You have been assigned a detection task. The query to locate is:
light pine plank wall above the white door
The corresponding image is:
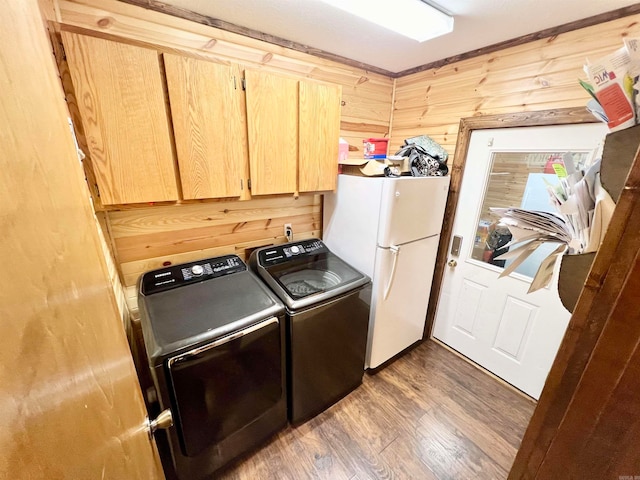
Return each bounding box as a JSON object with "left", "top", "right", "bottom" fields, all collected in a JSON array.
[{"left": 389, "top": 15, "right": 640, "bottom": 158}]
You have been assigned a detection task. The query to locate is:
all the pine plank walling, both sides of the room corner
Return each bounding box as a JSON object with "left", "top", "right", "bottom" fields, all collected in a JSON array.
[{"left": 52, "top": 0, "right": 640, "bottom": 316}]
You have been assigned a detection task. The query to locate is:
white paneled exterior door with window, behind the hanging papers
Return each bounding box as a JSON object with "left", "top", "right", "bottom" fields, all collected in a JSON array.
[{"left": 433, "top": 124, "right": 607, "bottom": 399}]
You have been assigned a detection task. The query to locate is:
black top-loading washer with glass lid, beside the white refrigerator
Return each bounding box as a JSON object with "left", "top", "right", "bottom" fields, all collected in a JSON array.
[{"left": 249, "top": 239, "right": 371, "bottom": 424}]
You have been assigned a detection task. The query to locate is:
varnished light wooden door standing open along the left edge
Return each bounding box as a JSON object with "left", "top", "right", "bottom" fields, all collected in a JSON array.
[{"left": 0, "top": 0, "right": 163, "bottom": 480}]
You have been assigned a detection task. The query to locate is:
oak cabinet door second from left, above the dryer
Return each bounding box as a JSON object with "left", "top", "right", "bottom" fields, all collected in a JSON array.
[{"left": 163, "top": 54, "right": 248, "bottom": 199}]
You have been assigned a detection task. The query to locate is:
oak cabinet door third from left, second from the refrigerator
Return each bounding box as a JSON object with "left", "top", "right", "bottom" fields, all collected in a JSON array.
[{"left": 245, "top": 70, "right": 298, "bottom": 195}]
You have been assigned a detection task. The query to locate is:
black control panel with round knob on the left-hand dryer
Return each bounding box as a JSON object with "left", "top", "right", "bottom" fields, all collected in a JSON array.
[{"left": 141, "top": 255, "right": 247, "bottom": 295}]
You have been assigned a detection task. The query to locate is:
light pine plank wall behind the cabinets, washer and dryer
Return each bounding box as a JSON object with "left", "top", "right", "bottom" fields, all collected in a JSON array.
[{"left": 52, "top": 0, "right": 393, "bottom": 313}]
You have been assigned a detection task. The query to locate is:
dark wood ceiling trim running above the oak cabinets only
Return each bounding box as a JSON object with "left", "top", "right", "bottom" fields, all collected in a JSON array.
[{"left": 119, "top": 0, "right": 396, "bottom": 78}]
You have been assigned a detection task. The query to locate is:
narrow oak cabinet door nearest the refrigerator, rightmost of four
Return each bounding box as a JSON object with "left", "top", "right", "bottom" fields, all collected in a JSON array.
[{"left": 298, "top": 81, "right": 342, "bottom": 192}]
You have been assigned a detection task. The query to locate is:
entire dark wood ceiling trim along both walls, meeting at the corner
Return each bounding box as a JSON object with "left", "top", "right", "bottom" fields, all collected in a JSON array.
[{"left": 119, "top": 0, "right": 640, "bottom": 78}]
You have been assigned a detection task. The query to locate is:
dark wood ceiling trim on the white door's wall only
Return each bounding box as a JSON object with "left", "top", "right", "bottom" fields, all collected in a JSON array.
[{"left": 394, "top": 3, "right": 640, "bottom": 78}]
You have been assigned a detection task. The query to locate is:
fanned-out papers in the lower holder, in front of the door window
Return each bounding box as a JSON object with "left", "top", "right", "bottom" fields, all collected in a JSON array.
[{"left": 490, "top": 161, "right": 615, "bottom": 293}]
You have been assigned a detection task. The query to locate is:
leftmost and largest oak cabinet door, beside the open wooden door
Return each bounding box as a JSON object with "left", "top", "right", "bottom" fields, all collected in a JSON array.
[{"left": 62, "top": 32, "right": 178, "bottom": 204}]
